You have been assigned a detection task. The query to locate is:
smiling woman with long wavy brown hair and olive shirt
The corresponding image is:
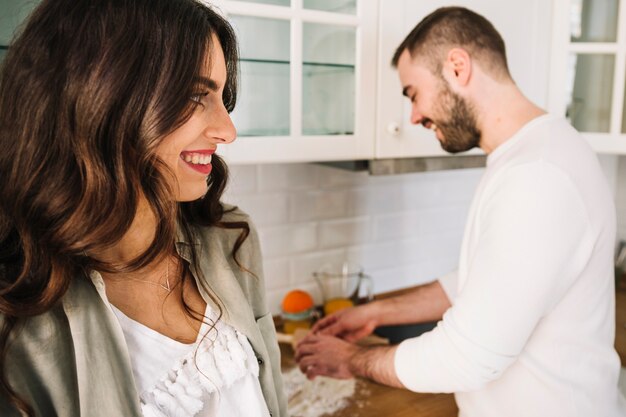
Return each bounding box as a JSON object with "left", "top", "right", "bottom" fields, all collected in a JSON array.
[{"left": 0, "top": 0, "right": 286, "bottom": 417}]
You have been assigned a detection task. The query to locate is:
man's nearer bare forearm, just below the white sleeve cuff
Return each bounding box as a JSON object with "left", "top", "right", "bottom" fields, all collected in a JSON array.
[{"left": 349, "top": 346, "right": 404, "bottom": 388}]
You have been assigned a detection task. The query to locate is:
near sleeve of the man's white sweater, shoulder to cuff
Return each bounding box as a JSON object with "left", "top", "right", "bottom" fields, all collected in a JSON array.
[{"left": 394, "top": 162, "right": 594, "bottom": 392}]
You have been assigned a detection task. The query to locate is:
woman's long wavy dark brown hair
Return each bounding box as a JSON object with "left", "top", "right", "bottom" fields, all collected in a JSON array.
[{"left": 0, "top": 0, "right": 249, "bottom": 415}]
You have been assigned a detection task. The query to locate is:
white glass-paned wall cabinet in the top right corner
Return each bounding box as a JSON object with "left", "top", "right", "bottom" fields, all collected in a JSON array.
[{"left": 549, "top": 0, "right": 626, "bottom": 154}]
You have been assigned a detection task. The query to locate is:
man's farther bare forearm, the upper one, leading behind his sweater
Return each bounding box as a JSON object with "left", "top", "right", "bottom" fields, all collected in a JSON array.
[{"left": 371, "top": 281, "right": 451, "bottom": 326}]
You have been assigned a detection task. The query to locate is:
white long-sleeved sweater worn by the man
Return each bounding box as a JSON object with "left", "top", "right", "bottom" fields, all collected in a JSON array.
[{"left": 395, "top": 115, "right": 626, "bottom": 417}]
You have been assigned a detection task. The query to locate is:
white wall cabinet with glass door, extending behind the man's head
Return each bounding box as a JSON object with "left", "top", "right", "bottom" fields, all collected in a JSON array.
[{"left": 217, "top": 0, "right": 552, "bottom": 163}]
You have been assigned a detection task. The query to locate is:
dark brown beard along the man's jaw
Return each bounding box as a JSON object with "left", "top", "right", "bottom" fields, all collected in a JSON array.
[{"left": 435, "top": 81, "right": 481, "bottom": 153}]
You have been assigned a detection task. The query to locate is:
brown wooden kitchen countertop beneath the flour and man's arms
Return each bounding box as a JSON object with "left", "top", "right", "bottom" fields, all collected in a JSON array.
[{"left": 281, "top": 288, "right": 626, "bottom": 417}]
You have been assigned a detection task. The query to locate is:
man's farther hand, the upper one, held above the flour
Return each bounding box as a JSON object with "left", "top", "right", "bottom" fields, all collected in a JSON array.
[{"left": 311, "top": 303, "right": 378, "bottom": 342}]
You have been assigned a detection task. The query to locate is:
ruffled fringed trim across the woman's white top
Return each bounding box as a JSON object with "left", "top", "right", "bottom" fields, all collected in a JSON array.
[{"left": 140, "top": 318, "right": 259, "bottom": 417}]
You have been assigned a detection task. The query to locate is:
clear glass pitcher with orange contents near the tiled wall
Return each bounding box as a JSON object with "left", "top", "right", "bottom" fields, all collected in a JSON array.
[{"left": 313, "top": 262, "right": 374, "bottom": 315}]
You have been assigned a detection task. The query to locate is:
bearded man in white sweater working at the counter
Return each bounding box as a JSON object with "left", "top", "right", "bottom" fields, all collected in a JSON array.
[{"left": 296, "top": 7, "right": 626, "bottom": 417}]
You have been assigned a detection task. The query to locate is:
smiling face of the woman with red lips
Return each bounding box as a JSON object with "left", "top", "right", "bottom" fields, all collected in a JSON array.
[{"left": 156, "top": 35, "right": 237, "bottom": 201}]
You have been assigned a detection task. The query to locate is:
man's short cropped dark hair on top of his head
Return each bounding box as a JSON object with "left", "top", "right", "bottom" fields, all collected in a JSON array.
[{"left": 391, "top": 7, "right": 511, "bottom": 79}]
